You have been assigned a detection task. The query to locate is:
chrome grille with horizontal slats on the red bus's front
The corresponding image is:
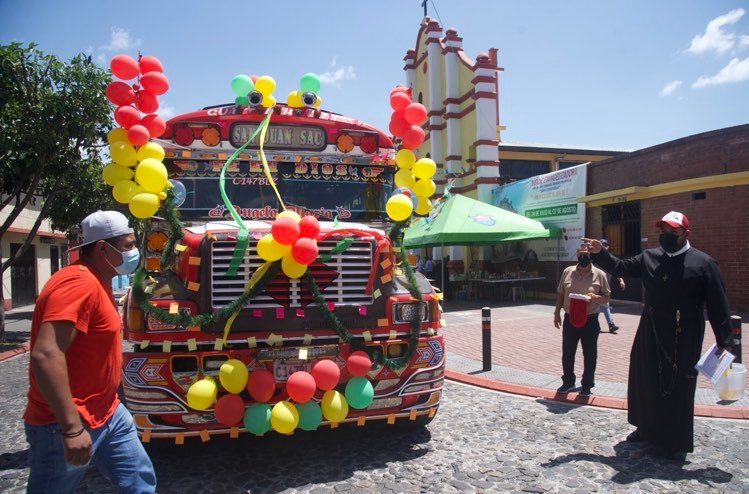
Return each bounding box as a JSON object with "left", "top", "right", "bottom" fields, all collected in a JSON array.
[{"left": 211, "top": 239, "right": 374, "bottom": 309}]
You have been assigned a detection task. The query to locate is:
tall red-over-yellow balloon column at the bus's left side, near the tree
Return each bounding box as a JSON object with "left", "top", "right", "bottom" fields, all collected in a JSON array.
[{"left": 102, "top": 55, "right": 169, "bottom": 218}]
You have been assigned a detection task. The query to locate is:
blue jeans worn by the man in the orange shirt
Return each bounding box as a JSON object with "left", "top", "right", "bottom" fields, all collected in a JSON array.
[{"left": 25, "top": 403, "right": 156, "bottom": 493}]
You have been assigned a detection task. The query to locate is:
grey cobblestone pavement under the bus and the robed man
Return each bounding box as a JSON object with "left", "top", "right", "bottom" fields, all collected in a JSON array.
[{"left": 0, "top": 354, "right": 749, "bottom": 494}]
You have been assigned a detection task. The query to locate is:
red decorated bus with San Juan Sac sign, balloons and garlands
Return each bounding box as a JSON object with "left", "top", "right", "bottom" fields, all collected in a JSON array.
[{"left": 113, "top": 68, "right": 445, "bottom": 443}]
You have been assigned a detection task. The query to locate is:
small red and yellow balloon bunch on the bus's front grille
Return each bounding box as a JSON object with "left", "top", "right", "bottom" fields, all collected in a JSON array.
[{"left": 257, "top": 211, "right": 320, "bottom": 279}]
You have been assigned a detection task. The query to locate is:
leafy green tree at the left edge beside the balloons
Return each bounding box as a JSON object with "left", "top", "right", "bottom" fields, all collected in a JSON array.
[{"left": 0, "top": 43, "right": 112, "bottom": 340}]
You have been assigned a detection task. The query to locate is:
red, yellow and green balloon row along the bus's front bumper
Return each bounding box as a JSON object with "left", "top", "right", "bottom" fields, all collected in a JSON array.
[{"left": 187, "top": 350, "right": 374, "bottom": 434}]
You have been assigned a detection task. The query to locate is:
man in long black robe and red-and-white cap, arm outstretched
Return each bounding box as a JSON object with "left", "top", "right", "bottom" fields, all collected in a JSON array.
[{"left": 583, "top": 211, "right": 731, "bottom": 457}]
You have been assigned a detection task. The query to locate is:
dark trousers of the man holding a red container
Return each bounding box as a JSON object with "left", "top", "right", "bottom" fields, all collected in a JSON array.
[{"left": 562, "top": 314, "right": 601, "bottom": 388}]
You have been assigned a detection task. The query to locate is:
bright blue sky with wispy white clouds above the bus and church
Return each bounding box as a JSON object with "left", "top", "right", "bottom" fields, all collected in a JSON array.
[{"left": 0, "top": 0, "right": 749, "bottom": 150}]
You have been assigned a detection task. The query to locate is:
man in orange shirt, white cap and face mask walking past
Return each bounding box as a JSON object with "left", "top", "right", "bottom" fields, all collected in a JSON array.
[{"left": 23, "top": 211, "right": 156, "bottom": 493}]
